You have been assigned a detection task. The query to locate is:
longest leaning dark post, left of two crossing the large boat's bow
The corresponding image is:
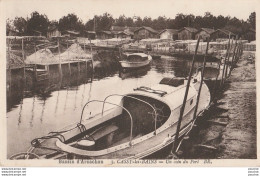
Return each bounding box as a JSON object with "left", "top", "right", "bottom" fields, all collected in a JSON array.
[{"left": 173, "top": 36, "right": 200, "bottom": 152}]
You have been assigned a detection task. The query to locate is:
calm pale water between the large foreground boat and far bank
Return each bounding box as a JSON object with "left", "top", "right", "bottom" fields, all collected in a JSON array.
[{"left": 7, "top": 57, "right": 211, "bottom": 157}]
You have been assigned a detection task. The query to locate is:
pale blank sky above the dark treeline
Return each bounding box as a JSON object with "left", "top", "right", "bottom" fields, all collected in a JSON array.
[{"left": 3, "top": 0, "right": 257, "bottom": 23}]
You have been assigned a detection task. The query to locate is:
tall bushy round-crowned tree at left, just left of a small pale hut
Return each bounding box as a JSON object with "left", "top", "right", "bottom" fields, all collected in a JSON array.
[{"left": 27, "top": 11, "right": 49, "bottom": 35}]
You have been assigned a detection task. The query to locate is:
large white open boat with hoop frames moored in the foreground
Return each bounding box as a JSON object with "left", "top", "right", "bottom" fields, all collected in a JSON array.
[{"left": 11, "top": 74, "right": 210, "bottom": 159}]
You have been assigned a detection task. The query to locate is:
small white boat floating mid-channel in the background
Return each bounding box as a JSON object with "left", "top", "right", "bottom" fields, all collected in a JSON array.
[{"left": 119, "top": 53, "right": 152, "bottom": 70}]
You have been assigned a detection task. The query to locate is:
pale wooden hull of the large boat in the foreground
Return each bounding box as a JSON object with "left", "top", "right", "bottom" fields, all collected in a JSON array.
[{"left": 18, "top": 82, "right": 210, "bottom": 159}]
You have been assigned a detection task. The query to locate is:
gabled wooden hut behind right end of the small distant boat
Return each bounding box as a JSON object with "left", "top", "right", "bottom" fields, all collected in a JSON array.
[{"left": 134, "top": 26, "right": 158, "bottom": 40}]
